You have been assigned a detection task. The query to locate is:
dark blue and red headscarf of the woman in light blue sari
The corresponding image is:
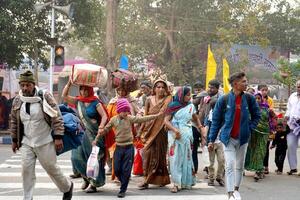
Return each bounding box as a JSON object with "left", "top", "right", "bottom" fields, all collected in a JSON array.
[{"left": 166, "top": 86, "right": 191, "bottom": 115}]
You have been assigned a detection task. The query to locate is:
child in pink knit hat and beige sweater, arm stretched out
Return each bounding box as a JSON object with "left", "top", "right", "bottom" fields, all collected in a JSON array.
[{"left": 93, "top": 98, "right": 163, "bottom": 198}]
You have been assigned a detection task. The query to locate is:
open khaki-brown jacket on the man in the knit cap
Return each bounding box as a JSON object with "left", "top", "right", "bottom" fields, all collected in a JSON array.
[{"left": 10, "top": 92, "right": 64, "bottom": 147}]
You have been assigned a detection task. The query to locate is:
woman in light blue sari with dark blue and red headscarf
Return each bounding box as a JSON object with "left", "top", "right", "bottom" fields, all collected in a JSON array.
[{"left": 165, "top": 87, "right": 202, "bottom": 193}]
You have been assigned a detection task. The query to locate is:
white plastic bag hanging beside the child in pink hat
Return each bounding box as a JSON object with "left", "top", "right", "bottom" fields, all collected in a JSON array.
[{"left": 86, "top": 146, "right": 99, "bottom": 180}]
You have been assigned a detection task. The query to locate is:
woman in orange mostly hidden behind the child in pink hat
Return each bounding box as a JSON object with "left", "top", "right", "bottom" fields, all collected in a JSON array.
[{"left": 105, "top": 87, "right": 139, "bottom": 180}]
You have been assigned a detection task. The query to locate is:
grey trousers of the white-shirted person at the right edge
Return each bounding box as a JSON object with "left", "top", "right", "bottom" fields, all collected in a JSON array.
[{"left": 287, "top": 132, "right": 300, "bottom": 169}]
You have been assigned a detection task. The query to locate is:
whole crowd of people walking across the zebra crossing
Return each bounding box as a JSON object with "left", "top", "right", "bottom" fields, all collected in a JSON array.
[{"left": 10, "top": 71, "right": 300, "bottom": 200}]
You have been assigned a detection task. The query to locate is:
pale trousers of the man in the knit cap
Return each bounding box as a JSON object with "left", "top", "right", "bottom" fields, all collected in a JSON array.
[{"left": 20, "top": 142, "right": 71, "bottom": 200}]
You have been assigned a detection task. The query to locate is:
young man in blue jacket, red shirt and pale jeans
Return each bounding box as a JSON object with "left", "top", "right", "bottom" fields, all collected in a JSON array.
[{"left": 208, "top": 72, "right": 261, "bottom": 200}]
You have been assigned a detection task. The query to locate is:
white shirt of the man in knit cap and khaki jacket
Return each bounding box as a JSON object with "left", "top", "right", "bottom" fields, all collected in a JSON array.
[{"left": 20, "top": 102, "right": 53, "bottom": 147}]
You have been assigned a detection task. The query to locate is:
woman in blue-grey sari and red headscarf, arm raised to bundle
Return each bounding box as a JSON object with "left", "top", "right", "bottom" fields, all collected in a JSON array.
[{"left": 62, "top": 81, "right": 108, "bottom": 193}]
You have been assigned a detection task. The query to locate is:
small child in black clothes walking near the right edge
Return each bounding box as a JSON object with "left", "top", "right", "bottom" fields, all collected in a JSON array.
[{"left": 271, "top": 122, "right": 290, "bottom": 175}]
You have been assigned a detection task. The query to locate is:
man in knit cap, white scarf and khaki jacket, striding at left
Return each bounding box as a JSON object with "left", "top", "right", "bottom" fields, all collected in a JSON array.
[{"left": 10, "top": 71, "right": 73, "bottom": 200}]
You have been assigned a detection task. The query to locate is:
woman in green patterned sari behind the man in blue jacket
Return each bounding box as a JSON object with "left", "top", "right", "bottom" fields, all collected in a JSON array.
[{"left": 245, "top": 93, "right": 275, "bottom": 181}]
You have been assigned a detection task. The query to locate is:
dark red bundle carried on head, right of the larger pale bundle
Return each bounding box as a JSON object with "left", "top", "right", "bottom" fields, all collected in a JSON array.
[{"left": 111, "top": 69, "right": 138, "bottom": 92}]
